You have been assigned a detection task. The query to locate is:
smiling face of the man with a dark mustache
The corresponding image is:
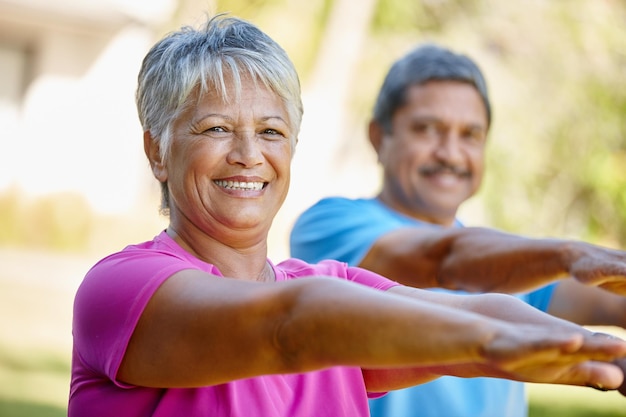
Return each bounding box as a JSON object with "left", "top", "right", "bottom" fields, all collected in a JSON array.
[{"left": 370, "top": 81, "right": 488, "bottom": 225}]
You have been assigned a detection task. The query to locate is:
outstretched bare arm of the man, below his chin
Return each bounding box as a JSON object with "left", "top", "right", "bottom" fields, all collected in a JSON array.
[{"left": 359, "top": 227, "right": 626, "bottom": 295}]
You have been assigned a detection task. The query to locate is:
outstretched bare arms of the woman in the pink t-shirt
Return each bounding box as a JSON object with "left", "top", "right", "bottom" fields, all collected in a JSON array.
[{"left": 118, "top": 270, "right": 626, "bottom": 389}]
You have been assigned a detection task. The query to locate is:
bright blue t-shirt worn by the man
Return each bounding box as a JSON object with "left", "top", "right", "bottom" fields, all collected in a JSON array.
[{"left": 290, "top": 197, "right": 555, "bottom": 417}]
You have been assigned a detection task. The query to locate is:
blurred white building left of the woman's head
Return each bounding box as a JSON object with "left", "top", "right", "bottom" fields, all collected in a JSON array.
[{"left": 0, "top": 0, "right": 176, "bottom": 213}]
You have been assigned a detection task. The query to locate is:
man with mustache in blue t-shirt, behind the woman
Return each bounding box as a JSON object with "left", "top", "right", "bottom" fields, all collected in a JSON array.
[{"left": 290, "top": 45, "right": 626, "bottom": 417}]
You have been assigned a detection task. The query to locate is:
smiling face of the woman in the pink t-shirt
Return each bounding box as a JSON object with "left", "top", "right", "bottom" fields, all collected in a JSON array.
[{"left": 159, "top": 78, "right": 294, "bottom": 240}]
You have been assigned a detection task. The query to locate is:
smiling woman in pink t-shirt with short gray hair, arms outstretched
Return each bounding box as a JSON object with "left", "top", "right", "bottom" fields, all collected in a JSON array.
[{"left": 68, "top": 11, "right": 626, "bottom": 417}]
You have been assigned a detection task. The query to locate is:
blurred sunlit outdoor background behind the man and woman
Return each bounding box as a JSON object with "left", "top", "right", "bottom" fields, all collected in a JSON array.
[{"left": 0, "top": 0, "right": 626, "bottom": 417}]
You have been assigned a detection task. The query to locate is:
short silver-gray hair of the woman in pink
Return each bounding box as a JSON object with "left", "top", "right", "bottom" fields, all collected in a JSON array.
[{"left": 136, "top": 14, "right": 303, "bottom": 213}]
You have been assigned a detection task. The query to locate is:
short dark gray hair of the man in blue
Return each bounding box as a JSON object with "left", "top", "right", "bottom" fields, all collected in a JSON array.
[{"left": 374, "top": 44, "right": 492, "bottom": 133}]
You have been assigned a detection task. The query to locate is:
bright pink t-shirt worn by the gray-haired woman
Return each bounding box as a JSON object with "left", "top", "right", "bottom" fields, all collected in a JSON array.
[{"left": 68, "top": 232, "right": 397, "bottom": 417}]
